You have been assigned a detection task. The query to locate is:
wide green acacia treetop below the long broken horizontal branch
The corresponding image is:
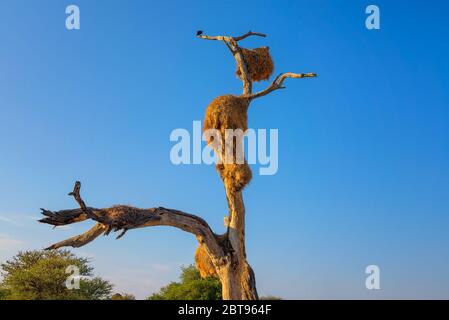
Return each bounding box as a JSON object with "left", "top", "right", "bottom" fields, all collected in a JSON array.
[{"left": 0, "top": 250, "right": 113, "bottom": 300}]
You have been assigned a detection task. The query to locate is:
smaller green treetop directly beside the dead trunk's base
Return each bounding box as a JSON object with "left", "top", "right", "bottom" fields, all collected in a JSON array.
[{"left": 148, "top": 265, "right": 222, "bottom": 300}]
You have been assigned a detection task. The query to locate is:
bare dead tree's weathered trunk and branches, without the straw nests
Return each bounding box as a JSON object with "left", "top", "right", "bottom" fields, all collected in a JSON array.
[{"left": 39, "top": 31, "right": 316, "bottom": 300}]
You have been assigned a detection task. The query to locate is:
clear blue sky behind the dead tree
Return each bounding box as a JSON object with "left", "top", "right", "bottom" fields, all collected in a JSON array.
[{"left": 0, "top": 0, "right": 449, "bottom": 299}]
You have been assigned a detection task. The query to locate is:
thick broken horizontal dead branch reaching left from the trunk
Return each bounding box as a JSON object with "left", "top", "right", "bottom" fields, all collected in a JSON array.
[{"left": 39, "top": 182, "right": 223, "bottom": 257}]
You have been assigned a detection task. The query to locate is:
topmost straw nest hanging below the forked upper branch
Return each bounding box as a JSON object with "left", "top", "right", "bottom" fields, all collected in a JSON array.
[{"left": 235, "top": 47, "right": 274, "bottom": 81}]
